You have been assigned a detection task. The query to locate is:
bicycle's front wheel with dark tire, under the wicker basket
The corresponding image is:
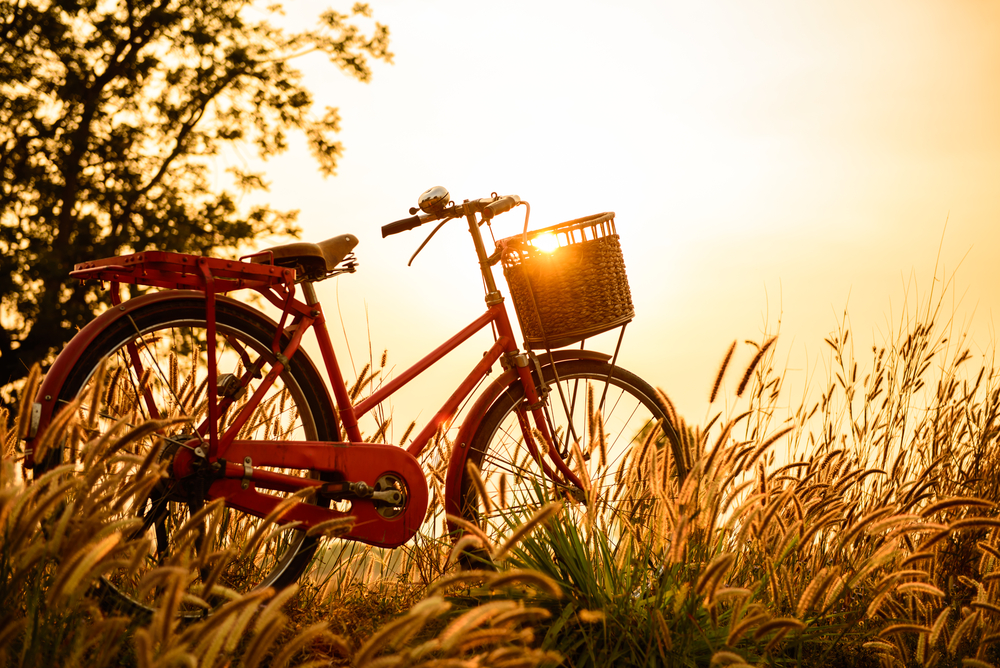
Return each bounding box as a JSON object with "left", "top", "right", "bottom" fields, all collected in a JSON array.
[{"left": 459, "top": 359, "right": 668, "bottom": 568}]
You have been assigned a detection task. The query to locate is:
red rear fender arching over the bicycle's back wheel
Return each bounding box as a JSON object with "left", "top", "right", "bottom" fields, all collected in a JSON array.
[{"left": 24, "top": 290, "right": 333, "bottom": 468}]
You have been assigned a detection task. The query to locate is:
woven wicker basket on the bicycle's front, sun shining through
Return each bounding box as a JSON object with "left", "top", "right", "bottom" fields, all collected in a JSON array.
[{"left": 497, "top": 213, "right": 635, "bottom": 348}]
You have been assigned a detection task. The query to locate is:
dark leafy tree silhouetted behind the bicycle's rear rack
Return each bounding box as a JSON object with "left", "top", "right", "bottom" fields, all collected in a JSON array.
[{"left": 0, "top": 0, "right": 392, "bottom": 402}]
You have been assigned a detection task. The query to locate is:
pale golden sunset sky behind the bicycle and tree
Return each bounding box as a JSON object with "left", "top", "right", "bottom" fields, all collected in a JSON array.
[{"left": 238, "top": 0, "right": 1000, "bottom": 430}]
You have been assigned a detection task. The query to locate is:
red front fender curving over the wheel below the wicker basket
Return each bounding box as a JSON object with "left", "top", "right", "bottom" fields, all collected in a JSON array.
[{"left": 444, "top": 350, "right": 611, "bottom": 531}]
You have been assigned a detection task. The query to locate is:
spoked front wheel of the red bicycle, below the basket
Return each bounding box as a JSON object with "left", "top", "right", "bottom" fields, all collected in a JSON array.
[{"left": 462, "top": 360, "right": 665, "bottom": 564}]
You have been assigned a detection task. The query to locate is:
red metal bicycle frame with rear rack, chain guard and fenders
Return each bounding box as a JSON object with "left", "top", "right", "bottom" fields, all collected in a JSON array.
[{"left": 26, "top": 197, "right": 588, "bottom": 547}]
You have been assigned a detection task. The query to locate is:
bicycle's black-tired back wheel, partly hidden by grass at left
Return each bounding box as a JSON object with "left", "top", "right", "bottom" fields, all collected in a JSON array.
[{"left": 45, "top": 298, "right": 340, "bottom": 617}]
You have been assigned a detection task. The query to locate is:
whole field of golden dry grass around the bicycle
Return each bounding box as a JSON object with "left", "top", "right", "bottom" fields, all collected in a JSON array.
[{"left": 0, "top": 284, "right": 1000, "bottom": 668}]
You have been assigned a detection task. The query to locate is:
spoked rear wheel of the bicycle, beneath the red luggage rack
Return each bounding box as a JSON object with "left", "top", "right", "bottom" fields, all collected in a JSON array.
[{"left": 45, "top": 298, "right": 339, "bottom": 616}]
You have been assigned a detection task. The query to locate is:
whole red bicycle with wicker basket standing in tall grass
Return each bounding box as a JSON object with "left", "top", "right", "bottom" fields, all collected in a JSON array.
[{"left": 27, "top": 188, "right": 666, "bottom": 616}]
